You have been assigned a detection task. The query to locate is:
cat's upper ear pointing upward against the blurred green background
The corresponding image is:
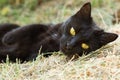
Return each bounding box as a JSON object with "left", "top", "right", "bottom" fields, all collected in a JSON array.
[{"left": 75, "top": 2, "right": 91, "bottom": 20}]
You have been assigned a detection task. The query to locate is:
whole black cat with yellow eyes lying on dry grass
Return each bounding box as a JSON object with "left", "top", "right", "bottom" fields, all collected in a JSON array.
[{"left": 0, "top": 2, "right": 118, "bottom": 62}]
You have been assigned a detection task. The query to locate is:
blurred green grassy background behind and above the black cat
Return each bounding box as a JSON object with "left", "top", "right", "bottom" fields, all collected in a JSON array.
[{"left": 0, "top": 0, "right": 120, "bottom": 26}]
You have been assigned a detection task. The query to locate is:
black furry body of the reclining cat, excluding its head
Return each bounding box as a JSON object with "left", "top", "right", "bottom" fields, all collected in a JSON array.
[{"left": 0, "top": 24, "right": 61, "bottom": 62}]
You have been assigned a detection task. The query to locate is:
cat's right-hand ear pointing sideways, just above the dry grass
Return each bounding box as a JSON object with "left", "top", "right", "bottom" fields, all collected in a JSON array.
[{"left": 99, "top": 32, "right": 118, "bottom": 45}]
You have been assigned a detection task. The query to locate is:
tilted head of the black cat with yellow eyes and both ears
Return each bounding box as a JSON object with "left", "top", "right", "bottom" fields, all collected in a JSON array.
[{"left": 60, "top": 2, "right": 118, "bottom": 56}]
